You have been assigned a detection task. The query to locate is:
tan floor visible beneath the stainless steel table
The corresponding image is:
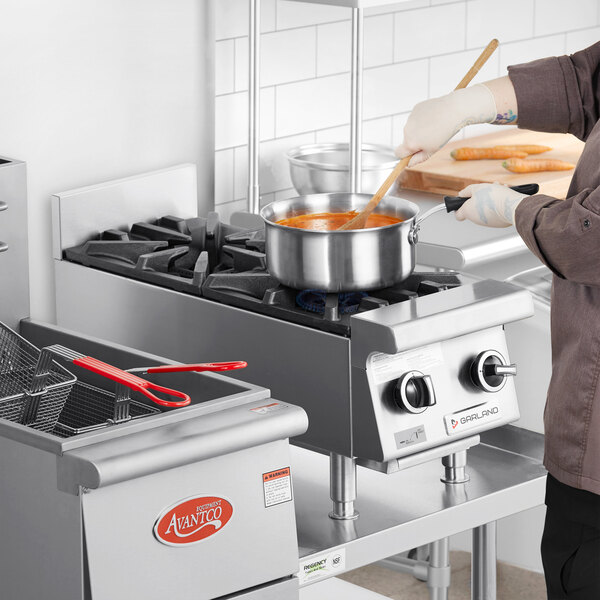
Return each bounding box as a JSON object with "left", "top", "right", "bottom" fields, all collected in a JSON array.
[{"left": 340, "top": 552, "right": 546, "bottom": 600}]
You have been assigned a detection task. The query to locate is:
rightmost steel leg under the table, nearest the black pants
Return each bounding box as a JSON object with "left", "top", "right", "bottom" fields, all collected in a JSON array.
[{"left": 471, "top": 521, "right": 496, "bottom": 600}]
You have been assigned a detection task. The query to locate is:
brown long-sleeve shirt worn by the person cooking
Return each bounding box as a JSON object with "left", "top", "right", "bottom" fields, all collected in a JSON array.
[{"left": 509, "top": 42, "right": 600, "bottom": 494}]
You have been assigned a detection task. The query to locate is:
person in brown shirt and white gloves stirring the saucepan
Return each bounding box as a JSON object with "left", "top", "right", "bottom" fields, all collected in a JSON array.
[{"left": 396, "top": 42, "right": 600, "bottom": 600}]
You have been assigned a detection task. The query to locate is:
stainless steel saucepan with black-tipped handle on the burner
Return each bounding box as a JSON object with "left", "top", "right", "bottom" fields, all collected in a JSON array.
[{"left": 260, "top": 185, "right": 537, "bottom": 292}]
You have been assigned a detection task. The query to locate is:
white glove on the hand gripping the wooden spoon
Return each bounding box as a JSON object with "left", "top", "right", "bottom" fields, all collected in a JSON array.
[{"left": 396, "top": 83, "right": 496, "bottom": 166}]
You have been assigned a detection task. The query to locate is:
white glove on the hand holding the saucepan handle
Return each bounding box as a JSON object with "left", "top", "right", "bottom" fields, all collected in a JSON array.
[{"left": 456, "top": 183, "right": 527, "bottom": 227}]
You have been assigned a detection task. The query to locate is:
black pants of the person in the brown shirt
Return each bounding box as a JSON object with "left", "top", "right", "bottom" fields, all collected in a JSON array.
[{"left": 542, "top": 475, "right": 600, "bottom": 600}]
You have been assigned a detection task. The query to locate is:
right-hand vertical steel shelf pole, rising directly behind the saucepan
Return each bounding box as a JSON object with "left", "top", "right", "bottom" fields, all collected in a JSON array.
[{"left": 350, "top": 8, "right": 363, "bottom": 193}]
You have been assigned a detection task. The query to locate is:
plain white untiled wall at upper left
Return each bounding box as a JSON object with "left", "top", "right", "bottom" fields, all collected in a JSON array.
[{"left": 0, "top": 0, "right": 213, "bottom": 320}]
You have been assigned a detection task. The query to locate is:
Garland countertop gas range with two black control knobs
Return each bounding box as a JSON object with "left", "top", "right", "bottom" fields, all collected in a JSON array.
[{"left": 54, "top": 166, "right": 533, "bottom": 518}]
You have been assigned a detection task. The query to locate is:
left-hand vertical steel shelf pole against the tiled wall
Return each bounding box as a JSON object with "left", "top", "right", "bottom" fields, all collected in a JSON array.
[{"left": 248, "top": 0, "right": 260, "bottom": 214}]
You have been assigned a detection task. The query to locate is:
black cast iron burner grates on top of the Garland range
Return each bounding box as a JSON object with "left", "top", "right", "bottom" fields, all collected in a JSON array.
[{"left": 64, "top": 213, "right": 461, "bottom": 337}]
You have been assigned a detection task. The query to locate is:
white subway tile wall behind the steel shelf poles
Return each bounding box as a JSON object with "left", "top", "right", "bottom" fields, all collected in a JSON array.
[{"left": 215, "top": 0, "right": 600, "bottom": 220}]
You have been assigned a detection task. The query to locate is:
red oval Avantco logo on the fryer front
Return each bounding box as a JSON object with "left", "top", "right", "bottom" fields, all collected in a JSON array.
[{"left": 154, "top": 496, "right": 233, "bottom": 546}]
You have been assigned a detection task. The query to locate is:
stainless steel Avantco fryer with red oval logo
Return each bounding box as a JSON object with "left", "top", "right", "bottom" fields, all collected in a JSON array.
[{"left": 0, "top": 322, "right": 307, "bottom": 600}]
